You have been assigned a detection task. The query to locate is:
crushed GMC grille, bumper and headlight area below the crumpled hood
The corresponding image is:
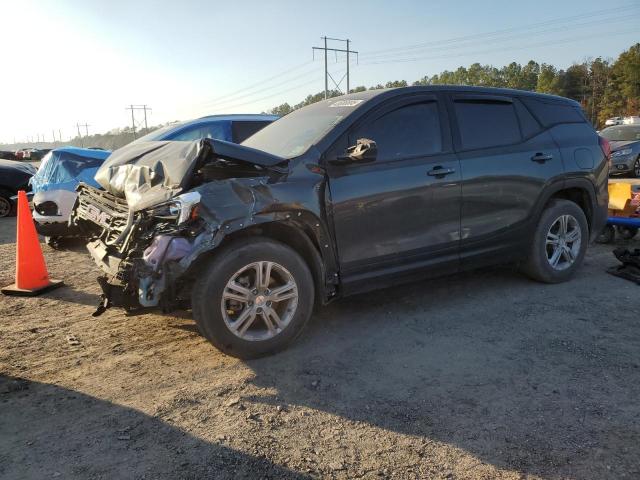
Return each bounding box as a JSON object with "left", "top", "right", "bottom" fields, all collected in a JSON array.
[{"left": 73, "top": 184, "right": 206, "bottom": 316}]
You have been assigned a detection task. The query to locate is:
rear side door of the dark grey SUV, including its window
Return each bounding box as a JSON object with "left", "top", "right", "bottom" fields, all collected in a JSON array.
[{"left": 449, "top": 94, "right": 564, "bottom": 267}]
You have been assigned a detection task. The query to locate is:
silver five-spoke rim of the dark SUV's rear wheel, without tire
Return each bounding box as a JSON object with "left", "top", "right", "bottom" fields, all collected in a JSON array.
[{"left": 546, "top": 215, "right": 582, "bottom": 270}]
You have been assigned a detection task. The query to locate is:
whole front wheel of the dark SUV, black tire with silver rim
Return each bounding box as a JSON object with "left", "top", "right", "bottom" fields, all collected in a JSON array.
[{"left": 191, "top": 237, "right": 315, "bottom": 359}]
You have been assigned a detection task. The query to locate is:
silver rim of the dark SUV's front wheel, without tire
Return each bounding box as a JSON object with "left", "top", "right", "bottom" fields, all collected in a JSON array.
[{"left": 220, "top": 261, "right": 298, "bottom": 341}]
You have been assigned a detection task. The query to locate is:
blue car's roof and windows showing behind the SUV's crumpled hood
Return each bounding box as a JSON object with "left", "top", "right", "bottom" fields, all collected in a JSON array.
[{"left": 136, "top": 114, "right": 279, "bottom": 143}]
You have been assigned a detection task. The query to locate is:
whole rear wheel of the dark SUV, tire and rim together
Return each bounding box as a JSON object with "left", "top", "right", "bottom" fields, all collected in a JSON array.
[{"left": 522, "top": 199, "right": 589, "bottom": 283}]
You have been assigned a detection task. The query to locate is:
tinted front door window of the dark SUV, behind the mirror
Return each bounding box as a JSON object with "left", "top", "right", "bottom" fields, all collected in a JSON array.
[{"left": 349, "top": 101, "right": 442, "bottom": 161}]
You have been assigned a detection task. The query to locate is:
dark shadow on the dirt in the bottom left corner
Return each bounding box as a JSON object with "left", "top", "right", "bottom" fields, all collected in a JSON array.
[{"left": 0, "top": 375, "right": 307, "bottom": 479}]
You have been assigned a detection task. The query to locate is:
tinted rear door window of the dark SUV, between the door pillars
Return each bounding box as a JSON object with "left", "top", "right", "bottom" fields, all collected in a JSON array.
[{"left": 454, "top": 99, "right": 522, "bottom": 150}]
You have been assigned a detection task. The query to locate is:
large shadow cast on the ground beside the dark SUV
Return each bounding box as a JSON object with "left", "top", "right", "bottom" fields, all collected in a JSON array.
[{"left": 240, "top": 262, "right": 640, "bottom": 479}]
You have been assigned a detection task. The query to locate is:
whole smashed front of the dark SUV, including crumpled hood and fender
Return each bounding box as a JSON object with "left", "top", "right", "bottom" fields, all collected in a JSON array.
[{"left": 71, "top": 140, "right": 298, "bottom": 315}]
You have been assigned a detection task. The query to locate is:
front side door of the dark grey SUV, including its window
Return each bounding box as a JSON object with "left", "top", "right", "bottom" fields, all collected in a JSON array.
[{"left": 328, "top": 95, "right": 460, "bottom": 289}]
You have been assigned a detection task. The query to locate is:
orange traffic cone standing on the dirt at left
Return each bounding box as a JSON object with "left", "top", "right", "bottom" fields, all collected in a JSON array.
[{"left": 2, "top": 190, "right": 62, "bottom": 297}]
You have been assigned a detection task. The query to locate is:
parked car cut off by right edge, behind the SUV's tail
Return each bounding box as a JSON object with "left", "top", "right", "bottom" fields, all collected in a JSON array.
[{"left": 600, "top": 124, "right": 640, "bottom": 178}]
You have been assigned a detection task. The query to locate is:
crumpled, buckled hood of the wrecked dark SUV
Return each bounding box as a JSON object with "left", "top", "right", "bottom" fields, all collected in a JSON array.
[{"left": 95, "top": 139, "right": 285, "bottom": 211}]
